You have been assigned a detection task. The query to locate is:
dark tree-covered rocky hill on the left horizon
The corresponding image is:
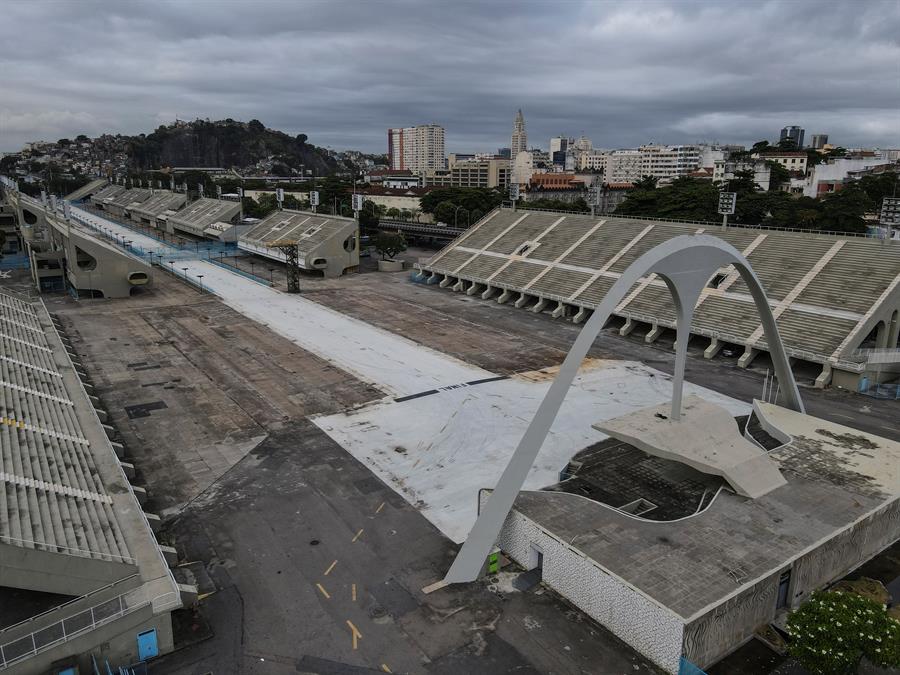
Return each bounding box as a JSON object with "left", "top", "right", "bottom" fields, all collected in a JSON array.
[{"left": 112, "top": 119, "right": 337, "bottom": 175}]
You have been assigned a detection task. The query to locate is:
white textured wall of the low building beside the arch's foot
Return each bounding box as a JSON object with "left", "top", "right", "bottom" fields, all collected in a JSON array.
[{"left": 499, "top": 509, "right": 683, "bottom": 673}]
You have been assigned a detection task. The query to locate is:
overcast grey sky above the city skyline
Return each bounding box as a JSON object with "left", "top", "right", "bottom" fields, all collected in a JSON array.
[{"left": 0, "top": 0, "right": 900, "bottom": 152}]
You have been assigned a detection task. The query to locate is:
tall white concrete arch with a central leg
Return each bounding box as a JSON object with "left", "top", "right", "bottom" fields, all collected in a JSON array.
[{"left": 444, "top": 235, "right": 805, "bottom": 583}]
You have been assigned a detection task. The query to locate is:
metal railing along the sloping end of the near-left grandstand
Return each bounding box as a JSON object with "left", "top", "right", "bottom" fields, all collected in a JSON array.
[{"left": 0, "top": 577, "right": 181, "bottom": 670}]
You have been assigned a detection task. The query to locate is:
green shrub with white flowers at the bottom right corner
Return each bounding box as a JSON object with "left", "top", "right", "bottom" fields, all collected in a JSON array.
[{"left": 787, "top": 591, "right": 900, "bottom": 675}]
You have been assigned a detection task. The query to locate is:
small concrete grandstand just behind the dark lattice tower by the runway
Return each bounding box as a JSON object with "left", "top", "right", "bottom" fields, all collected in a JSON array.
[{"left": 238, "top": 209, "right": 359, "bottom": 278}]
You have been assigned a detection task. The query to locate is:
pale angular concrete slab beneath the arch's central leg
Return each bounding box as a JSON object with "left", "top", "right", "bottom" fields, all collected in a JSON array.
[{"left": 592, "top": 395, "right": 786, "bottom": 498}]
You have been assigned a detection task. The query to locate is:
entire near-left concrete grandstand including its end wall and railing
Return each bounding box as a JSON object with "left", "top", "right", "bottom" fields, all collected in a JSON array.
[{"left": 0, "top": 293, "right": 184, "bottom": 672}]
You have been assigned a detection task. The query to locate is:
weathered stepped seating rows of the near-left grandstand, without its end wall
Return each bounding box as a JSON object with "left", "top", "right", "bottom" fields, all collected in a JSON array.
[{"left": 0, "top": 294, "right": 129, "bottom": 561}]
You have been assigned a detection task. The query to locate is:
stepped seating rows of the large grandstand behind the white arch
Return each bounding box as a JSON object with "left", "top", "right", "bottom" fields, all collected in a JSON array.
[{"left": 421, "top": 209, "right": 900, "bottom": 361}]
